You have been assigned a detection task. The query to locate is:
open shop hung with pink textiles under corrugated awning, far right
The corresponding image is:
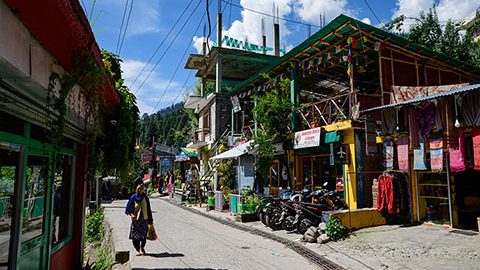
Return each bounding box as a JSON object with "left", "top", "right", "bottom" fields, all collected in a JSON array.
[{"left": 364, "top": 84, "right": 480, "bottom": 229}]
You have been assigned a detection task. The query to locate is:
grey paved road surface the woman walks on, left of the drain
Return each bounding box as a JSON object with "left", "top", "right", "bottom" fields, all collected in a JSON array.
[{"left": 104, "top": 199, "right": 317, "bottom": 270}]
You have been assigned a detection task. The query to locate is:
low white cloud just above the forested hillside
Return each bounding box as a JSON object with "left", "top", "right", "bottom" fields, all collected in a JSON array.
[{"left": 122, "top": 59, "right": 183, "bottom": 115}]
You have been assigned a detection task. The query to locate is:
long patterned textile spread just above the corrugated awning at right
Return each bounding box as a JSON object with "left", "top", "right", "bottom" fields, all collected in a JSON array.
[{"left": 390, "top": 83, "right": 469, "bottom": 104}]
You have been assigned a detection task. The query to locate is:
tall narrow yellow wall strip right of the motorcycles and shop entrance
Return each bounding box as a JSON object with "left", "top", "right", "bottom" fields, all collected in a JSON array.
[{"left": 343, "top": 129, "right": 357, "bottom": 209}]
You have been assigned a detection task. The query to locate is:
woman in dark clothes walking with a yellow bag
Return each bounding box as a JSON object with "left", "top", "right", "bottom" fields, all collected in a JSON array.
[{"left": 125, "top": 184, "right": 153, "bottom": 256}]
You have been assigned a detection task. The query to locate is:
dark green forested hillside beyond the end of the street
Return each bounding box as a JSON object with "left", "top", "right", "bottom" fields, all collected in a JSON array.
[{"left": 140, "top": 102, "right": 195, "bottom": 146}]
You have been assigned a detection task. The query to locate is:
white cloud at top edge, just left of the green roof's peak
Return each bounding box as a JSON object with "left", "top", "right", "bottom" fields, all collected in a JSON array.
[{"left": 295, "top": 0, "right": 354, "bottom": 25}]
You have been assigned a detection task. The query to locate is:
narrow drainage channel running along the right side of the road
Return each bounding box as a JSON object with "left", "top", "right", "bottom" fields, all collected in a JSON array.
[{"left": 165, "top": 200, "right": 345, "bottom": 270}]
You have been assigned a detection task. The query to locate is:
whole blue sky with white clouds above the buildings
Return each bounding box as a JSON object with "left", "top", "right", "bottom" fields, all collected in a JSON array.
[{"left": 80, "top": 0, "right": 480, "bottom": 115}]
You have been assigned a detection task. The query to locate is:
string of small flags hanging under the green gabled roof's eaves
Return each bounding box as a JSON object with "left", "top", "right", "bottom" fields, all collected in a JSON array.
[{"left": 234, "top": 36, "right": 386, "bottom": 98}]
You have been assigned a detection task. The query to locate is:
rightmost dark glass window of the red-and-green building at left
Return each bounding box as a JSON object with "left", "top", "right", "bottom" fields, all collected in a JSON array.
[{"left": 52, "top": 156, "right": 74, "bottom": 244}]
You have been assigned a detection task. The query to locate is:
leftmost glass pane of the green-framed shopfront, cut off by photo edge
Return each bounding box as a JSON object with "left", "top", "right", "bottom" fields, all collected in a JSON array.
[{"left": 0, "top": 142, "right": 20, "bottom": 269}]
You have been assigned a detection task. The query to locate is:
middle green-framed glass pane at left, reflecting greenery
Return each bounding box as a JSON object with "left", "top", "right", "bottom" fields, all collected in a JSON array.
[{"left": 22, "top": 156, "right": 48, "bottom": 242}]
